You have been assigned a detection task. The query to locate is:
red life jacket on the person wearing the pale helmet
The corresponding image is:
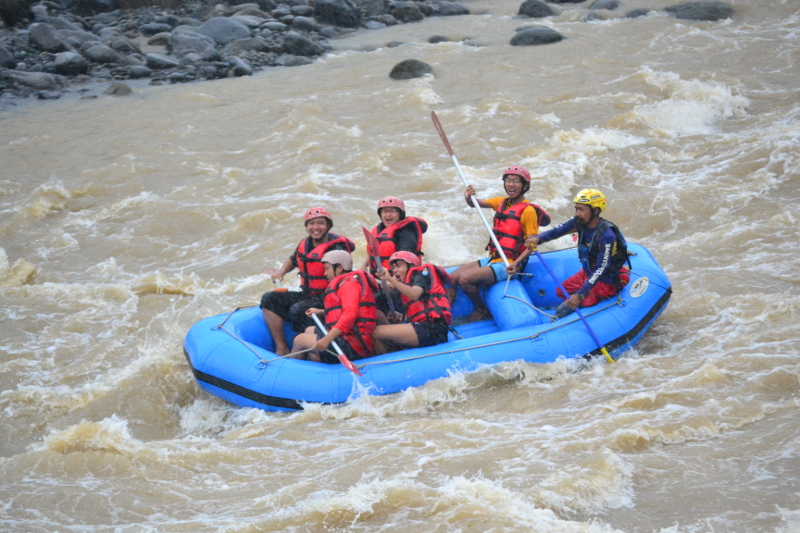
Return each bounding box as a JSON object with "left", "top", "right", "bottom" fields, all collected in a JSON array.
[{"left": 323, "top": 270, "right": 378, "bottom": 357}]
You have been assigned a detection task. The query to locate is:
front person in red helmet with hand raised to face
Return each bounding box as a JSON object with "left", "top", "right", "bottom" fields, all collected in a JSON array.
[{"left": 372, "top": 252, "right": 453, "bottom": 354}]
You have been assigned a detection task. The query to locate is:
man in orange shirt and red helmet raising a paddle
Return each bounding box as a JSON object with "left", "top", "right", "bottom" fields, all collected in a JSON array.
[{"left": 448, "top": 165, "right": 550, "bottom": 321}]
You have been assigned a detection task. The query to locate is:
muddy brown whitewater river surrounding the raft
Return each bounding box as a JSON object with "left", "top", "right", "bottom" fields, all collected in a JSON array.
[{"left": 0, "top": 0, "right": 800, "bottom": 533}]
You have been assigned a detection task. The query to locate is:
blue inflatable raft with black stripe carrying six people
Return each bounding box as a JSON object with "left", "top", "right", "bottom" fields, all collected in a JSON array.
[{"left": 184, "top": 244, "right": 672, "bottom": 411}]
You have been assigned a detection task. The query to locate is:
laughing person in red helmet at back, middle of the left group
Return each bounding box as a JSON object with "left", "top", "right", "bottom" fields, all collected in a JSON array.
[{"left": 368, "top": 196, "right": 428, "bottom": 274}]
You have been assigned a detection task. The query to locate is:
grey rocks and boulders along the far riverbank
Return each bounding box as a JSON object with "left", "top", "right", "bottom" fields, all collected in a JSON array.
[{"left": 0, "top": 0, "right": 733, "bottom": 103}]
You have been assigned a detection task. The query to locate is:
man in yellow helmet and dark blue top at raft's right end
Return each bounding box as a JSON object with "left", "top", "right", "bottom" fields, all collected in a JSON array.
[{"left": 525, "top": 189, "right": 630, "bottom": 318}]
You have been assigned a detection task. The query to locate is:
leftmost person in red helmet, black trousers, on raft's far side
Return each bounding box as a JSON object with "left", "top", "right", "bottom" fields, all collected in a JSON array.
[{"left": 261, "top": 207, "right": 356, "bottom": 355}]
